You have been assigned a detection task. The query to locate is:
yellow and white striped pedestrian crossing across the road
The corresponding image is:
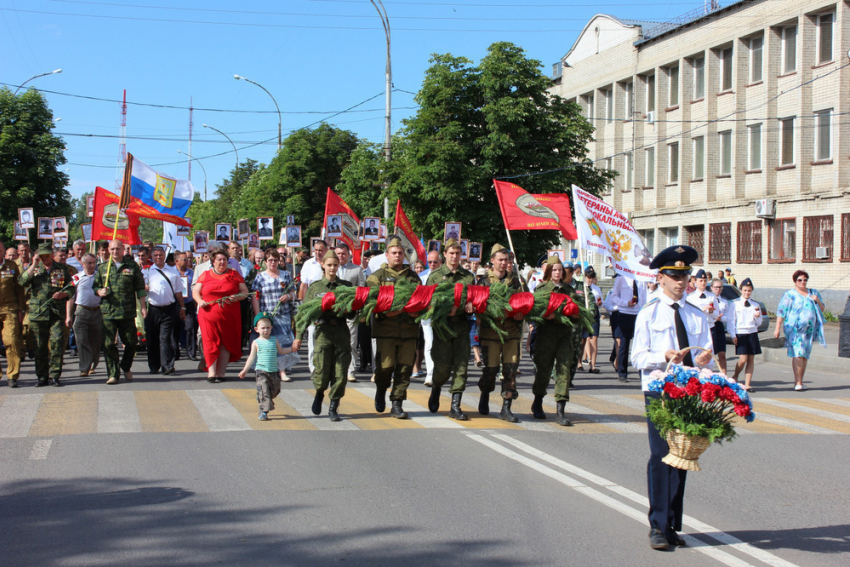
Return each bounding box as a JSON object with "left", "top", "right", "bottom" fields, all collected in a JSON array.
[{"left": 0, "top": 385, "right": 850, "bottom": 439}]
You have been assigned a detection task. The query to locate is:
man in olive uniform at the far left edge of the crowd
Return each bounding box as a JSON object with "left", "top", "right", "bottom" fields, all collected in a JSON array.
[{"left": 0, "top": 242, "right": 26, "bottom": 388}]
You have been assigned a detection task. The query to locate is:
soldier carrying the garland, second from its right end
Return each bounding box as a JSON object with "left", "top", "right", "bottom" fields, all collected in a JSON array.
[{"left": 478, "top": 244, "right": 525, "bottom": 423}]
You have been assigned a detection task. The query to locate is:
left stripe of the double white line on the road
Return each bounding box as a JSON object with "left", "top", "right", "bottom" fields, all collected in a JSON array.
[{"left": 466, "top": 433, "right": 756, "bottom": 567}]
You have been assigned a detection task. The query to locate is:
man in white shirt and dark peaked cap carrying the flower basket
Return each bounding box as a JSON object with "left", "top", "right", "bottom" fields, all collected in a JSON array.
[{"left": 618, "top": 246, "right": 711, "bottom": 550}]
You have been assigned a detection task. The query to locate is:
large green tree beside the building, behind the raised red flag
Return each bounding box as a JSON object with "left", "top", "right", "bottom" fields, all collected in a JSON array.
[{"left": 390, "top": 42, "right": 613, "bottom": 261}]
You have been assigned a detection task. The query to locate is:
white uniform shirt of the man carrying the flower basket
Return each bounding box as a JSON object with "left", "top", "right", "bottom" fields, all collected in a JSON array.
[{"left": 628, "top": 292, "right": 713, "bottom": 392}]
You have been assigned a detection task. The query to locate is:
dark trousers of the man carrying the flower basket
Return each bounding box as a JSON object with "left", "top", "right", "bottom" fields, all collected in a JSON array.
[{"left": 644, "top": 392, "right": 688, "bottom": 532}]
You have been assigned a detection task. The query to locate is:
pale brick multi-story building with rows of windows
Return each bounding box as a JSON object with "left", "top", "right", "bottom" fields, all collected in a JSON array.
[{"left": 551, "top": 0, "right": 850, "bottom": 314}]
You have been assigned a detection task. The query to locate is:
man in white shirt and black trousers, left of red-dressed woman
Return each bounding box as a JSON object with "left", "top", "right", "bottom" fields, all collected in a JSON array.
[{"left": 143, "top": 246, "right": 186, "bottom": 376}]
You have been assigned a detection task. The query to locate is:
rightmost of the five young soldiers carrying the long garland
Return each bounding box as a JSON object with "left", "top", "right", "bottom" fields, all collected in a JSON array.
[{"left": 531, "top": 256, "right": 581, "bottom": 426}]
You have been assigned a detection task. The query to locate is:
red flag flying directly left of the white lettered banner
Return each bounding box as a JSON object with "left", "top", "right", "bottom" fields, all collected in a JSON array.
[{"left": 493, "top": 179, "right": 578, "bottom": 240}]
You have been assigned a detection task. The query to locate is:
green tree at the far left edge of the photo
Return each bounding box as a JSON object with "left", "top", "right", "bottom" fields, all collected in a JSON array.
[{"left": 0, "top": 87, "right": 72, "bottom": 241}]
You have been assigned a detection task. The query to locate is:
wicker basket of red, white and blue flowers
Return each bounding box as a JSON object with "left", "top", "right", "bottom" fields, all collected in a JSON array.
[{"left": 646, "top": 347, "right": 755, "bottom": 471}]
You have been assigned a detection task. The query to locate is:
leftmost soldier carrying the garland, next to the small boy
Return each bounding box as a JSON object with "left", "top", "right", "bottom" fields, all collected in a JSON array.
[{"left": 292, "top": 250, "right": 354, "bottom": 421}]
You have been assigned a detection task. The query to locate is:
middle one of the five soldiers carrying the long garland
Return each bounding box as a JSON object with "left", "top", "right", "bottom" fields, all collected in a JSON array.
[{"left": 427, "top": 238, "right": 475, "bottom": 421}]
